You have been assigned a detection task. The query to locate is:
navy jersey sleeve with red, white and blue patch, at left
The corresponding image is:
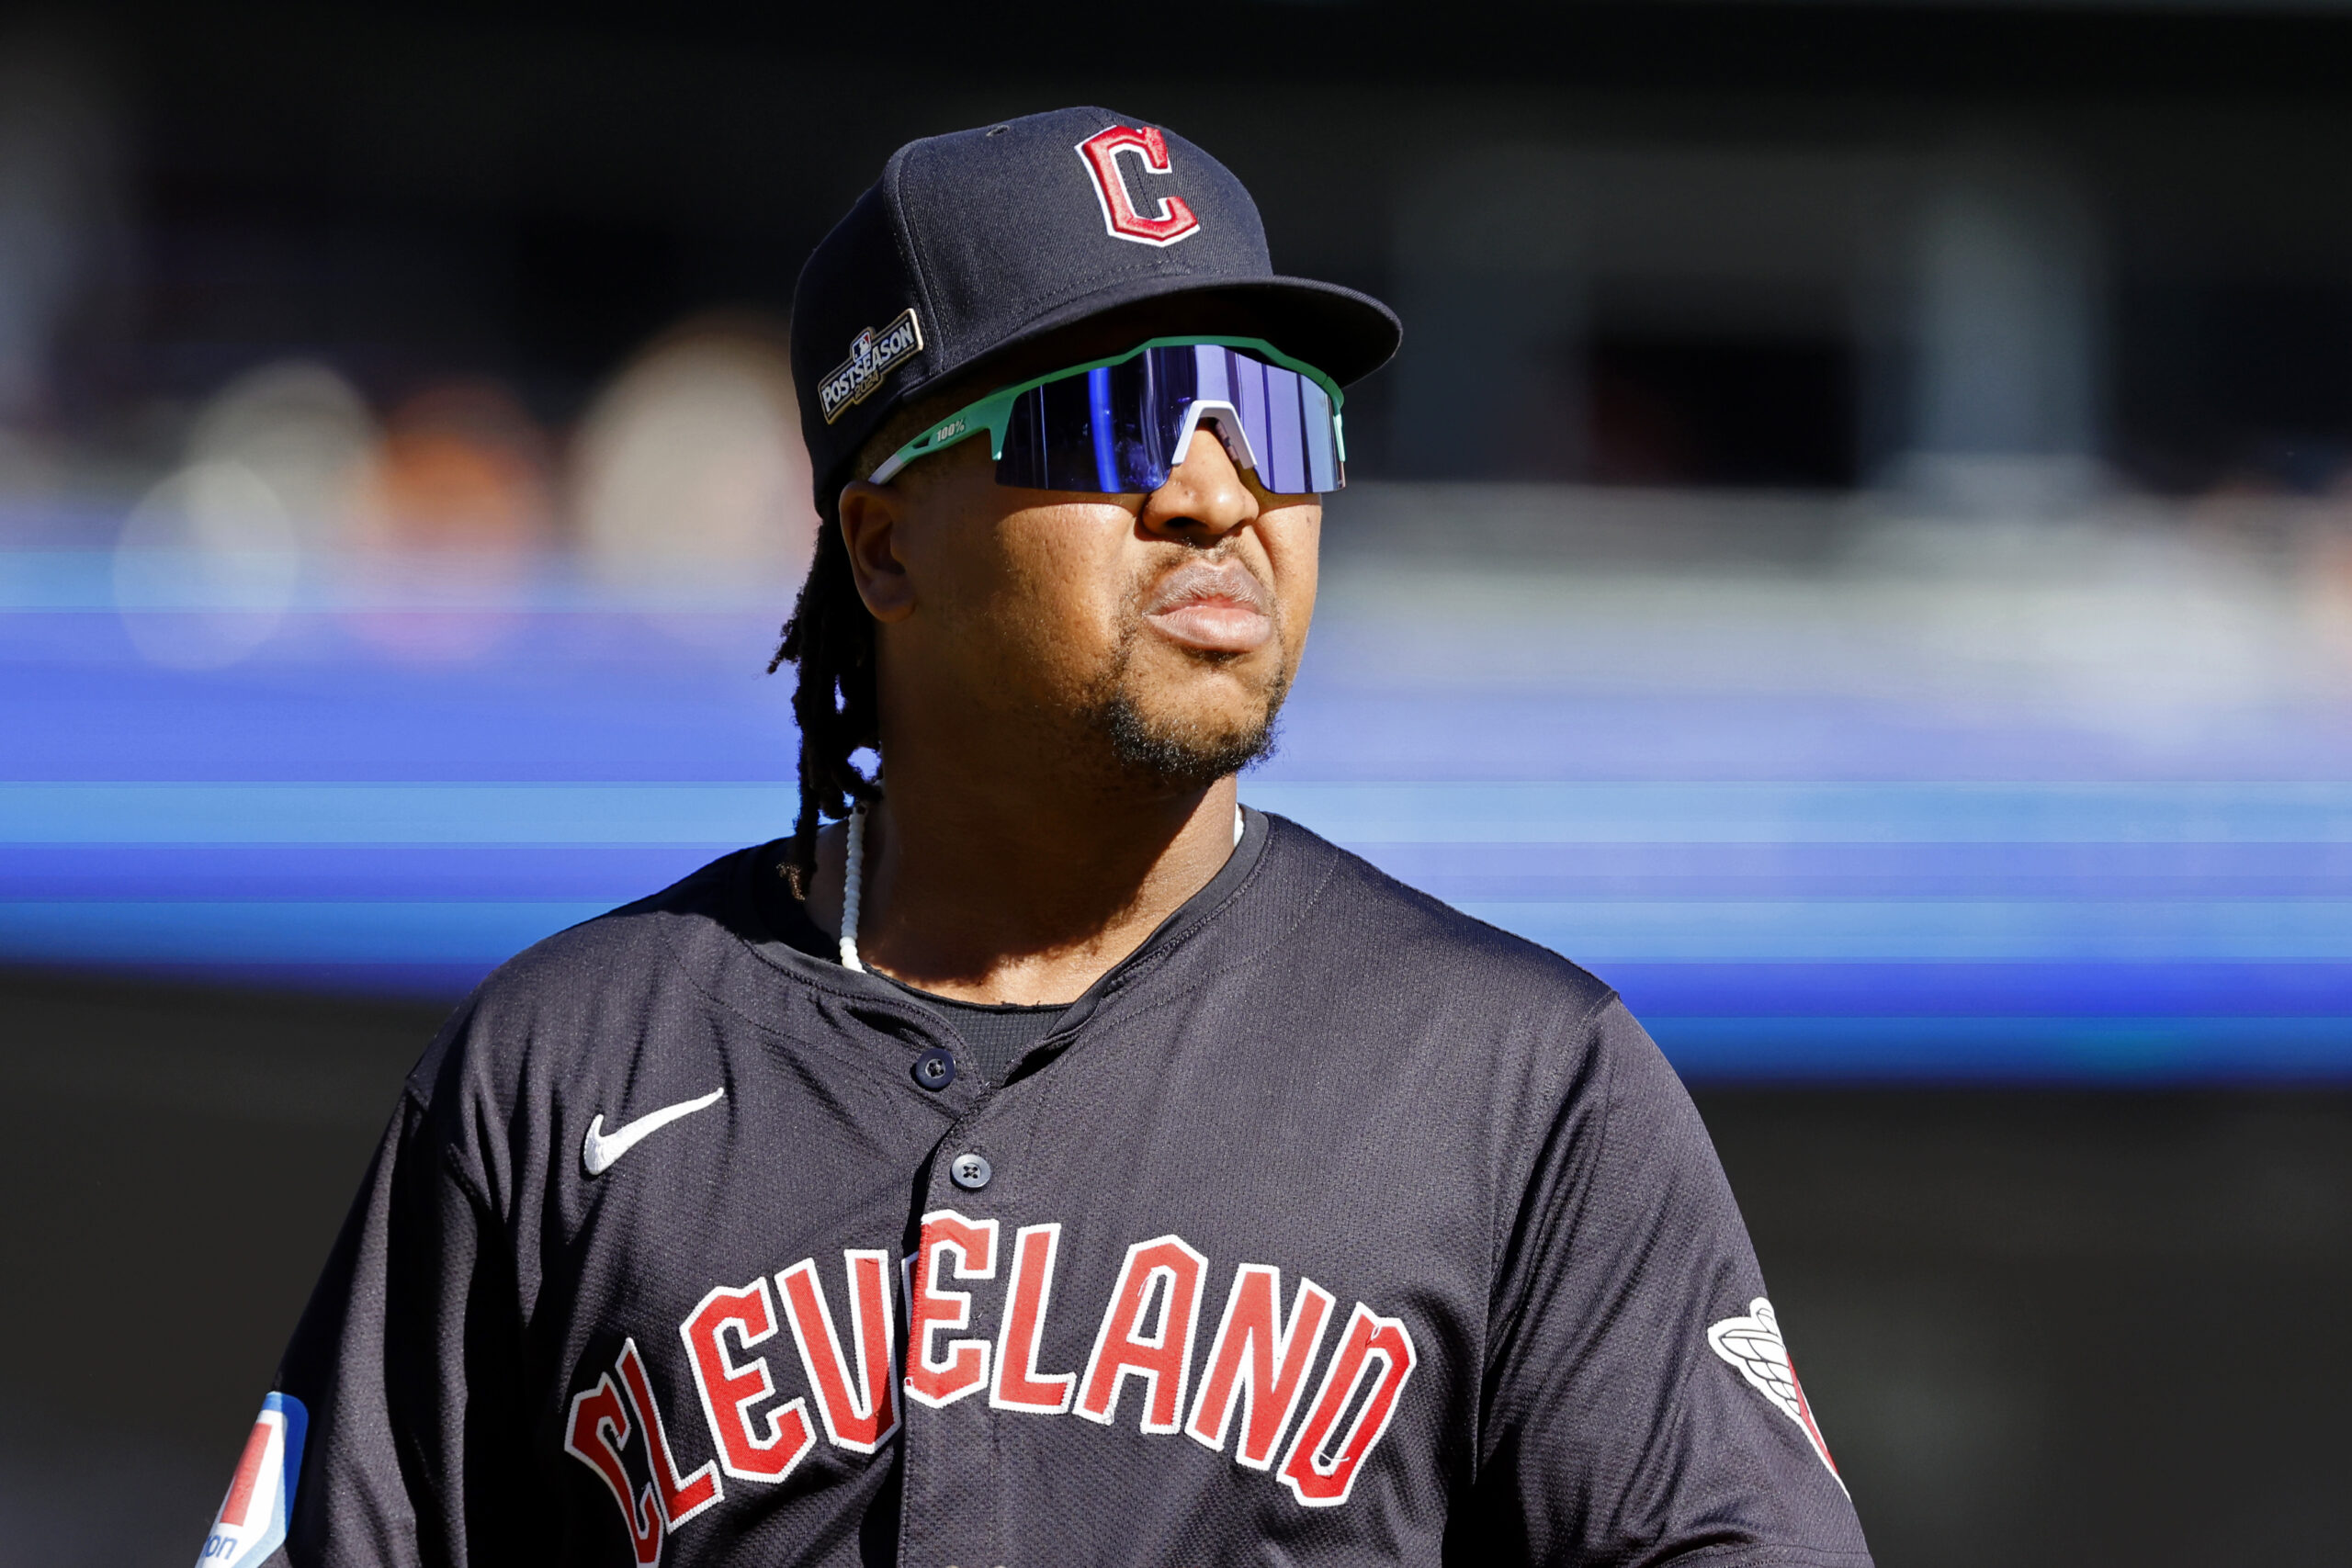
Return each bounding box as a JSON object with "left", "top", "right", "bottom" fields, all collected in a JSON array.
[{"left": 202, "top": 1020, "right": 529, "bottom": 1568}]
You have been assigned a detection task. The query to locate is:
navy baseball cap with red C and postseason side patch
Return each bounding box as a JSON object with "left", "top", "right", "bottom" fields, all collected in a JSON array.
[{"left": 793, "top": 108, "right": 1402, "bottom": 514}]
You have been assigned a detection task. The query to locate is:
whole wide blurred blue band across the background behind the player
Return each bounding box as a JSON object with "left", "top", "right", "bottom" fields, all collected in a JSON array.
[{"left": 0, "top": 526, "right": 2352, "bottom": 1081}]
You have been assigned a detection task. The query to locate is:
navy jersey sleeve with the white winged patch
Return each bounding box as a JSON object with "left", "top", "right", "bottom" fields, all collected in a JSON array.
[{"left": 1449, "top": 999, "right": 1870, "bottom": 1568}]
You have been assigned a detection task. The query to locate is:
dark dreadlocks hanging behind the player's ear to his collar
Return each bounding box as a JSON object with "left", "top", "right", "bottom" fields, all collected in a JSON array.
[{"left": 767, "top": 505, "right": 882, "bottom": 898}]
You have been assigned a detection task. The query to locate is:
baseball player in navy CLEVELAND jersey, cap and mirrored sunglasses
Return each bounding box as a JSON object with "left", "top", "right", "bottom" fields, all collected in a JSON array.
[{"left": 200, "top": 108, "right": 1870, "bottom": 1568}]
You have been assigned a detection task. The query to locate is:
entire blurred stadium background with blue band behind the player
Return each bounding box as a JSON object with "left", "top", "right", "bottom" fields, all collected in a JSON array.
[{"left": 0, "top": 0, "right": 2352, "bottom": 1568}]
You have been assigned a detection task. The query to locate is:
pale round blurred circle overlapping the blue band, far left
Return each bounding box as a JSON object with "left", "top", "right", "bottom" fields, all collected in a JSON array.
[{"left": 115, "top": 463, "right": 301, "bottom": 670}]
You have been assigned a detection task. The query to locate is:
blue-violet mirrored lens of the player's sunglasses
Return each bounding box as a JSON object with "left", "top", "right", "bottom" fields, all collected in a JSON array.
[{"left": 997, "top": 344, "right": 1348, "bottom": 496}]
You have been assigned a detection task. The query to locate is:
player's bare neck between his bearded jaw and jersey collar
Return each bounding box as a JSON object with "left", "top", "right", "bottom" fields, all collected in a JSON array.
[{"left": 809, "top": 748, "right": 1235, "bottom": 1004}]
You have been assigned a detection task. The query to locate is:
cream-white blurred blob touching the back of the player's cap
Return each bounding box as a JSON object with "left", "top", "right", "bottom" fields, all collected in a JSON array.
[{"left": 571, "top": 329, "right": 816, "bottom": 611}]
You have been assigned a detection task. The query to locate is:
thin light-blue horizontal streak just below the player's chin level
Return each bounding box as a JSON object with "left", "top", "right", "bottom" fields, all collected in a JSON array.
[{"left": 0, "top": 781, "right": 2352, "bottom": 846}]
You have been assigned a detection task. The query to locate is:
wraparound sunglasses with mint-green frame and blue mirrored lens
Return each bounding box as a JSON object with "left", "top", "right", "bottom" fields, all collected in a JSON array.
[{"left": 873, "top": 339, "right": 1348, "bottom": 496}]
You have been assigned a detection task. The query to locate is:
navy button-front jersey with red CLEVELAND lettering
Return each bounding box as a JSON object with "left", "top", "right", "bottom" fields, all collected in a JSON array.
[{"left": 205, "top": 811, "right": 1870, "bottom": 1568}]
